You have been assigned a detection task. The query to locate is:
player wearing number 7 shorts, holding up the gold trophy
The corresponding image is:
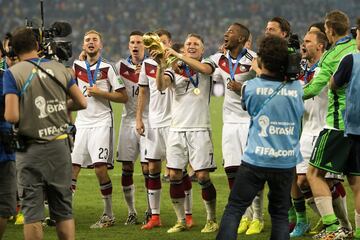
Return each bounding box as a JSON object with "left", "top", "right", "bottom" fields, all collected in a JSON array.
[{"left": 156, "top": 34, "right": 218, "bottom": 233}]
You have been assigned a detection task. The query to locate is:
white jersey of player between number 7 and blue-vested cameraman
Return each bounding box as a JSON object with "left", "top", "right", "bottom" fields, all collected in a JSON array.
[{"left": 205, "top": 49, "right": 256, "bottom": 123}]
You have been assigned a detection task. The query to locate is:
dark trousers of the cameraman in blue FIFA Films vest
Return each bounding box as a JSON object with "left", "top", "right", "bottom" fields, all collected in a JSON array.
[{"left": 216, "top": 162, "right": 295, "bottom": 240}]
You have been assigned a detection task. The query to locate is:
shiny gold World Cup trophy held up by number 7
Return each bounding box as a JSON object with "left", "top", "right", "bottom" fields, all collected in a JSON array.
[{"left": 143, "top": 32, "right": 177, "bottom": 67}]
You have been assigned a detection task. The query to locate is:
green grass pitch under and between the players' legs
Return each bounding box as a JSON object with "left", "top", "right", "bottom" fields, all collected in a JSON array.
[{"left": 3, "top": 97, "right": 354, "bottom": 240}]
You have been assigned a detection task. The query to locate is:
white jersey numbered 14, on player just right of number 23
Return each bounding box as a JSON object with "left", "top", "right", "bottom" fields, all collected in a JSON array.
[{"left": 115, "top": 59, "right": 149, "bottom": 126}]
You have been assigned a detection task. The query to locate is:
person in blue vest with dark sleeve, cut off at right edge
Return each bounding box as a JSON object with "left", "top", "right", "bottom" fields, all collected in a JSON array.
[{"left": 330, "top": 18, "right": 360, "bottom": 239}]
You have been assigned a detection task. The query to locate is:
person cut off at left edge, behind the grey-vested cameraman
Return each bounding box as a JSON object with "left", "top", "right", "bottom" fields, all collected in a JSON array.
[{"left": 0, "top": 33, "right": 16, "bottom": 239}]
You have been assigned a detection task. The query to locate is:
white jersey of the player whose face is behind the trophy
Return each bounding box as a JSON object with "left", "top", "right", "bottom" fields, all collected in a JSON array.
[{"left": 139, "top": 58, "right": 173, "bottom": 128}]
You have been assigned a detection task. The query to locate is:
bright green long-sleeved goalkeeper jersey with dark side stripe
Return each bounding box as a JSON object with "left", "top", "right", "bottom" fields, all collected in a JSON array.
[{"left": 304, "top": 36, "right": 356, "bottom": 130}]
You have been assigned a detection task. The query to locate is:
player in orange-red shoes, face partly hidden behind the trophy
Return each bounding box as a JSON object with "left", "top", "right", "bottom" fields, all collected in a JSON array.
[{"left": 136, "top": 29, "right": 192, "bottom": 230}]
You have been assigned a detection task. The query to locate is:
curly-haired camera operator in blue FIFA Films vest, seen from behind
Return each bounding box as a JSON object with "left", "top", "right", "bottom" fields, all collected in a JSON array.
[{"left": 217, "top": 35, "right": 304, "bottom": 240}]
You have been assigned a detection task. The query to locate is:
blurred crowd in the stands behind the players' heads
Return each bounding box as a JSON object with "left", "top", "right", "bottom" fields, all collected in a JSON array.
[{"left": 0, "top": 0, "right": 359, "bottom": 61}]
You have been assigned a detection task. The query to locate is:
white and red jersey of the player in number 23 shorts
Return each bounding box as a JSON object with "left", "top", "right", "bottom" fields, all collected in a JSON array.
[{"left": 73, "top": 59, "right": 125, "bottom": 128}]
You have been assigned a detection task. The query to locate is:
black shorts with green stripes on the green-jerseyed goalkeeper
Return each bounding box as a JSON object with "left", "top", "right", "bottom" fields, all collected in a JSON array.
[{"left": 309, "top": 129, "right": 360, "bottom": 175}]
